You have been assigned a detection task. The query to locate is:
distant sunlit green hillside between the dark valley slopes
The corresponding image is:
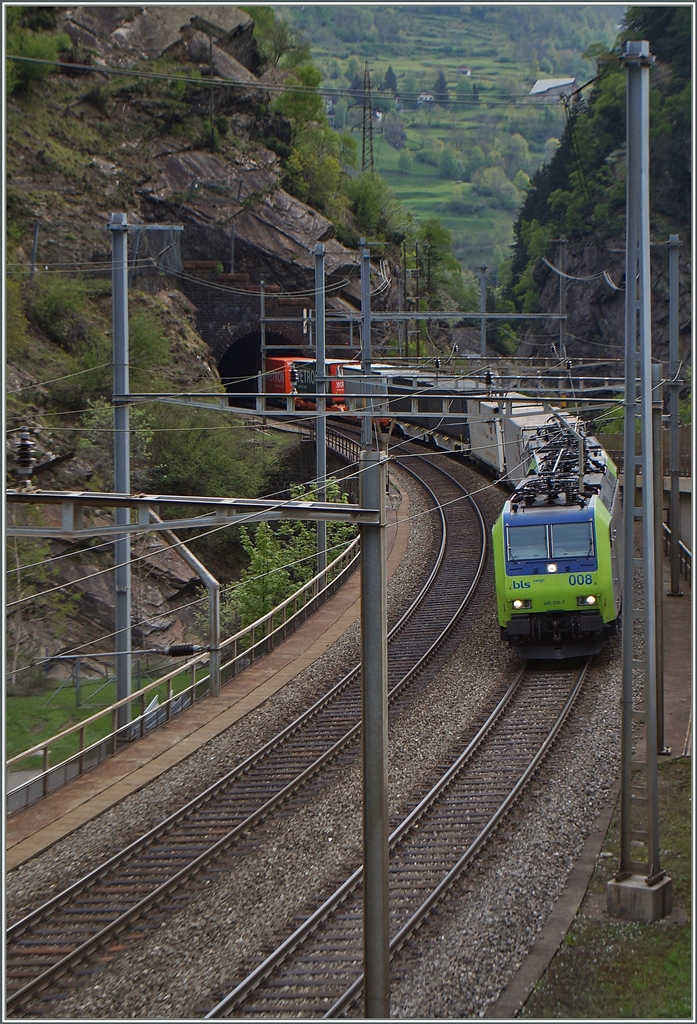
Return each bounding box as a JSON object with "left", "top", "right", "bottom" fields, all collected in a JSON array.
[{"left": 284, "top": 4, "right": 623, "bottom": 267}]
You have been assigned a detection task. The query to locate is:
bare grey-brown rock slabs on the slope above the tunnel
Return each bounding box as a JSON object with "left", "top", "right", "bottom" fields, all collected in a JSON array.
[{"left": 62, "top": 4, "right": 358, "bottom": 360}]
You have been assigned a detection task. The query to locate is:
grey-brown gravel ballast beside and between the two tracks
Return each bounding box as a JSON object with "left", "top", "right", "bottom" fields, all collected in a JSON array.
[{"left": 8, "top": 464, "right": 619, "bottom": 1019}]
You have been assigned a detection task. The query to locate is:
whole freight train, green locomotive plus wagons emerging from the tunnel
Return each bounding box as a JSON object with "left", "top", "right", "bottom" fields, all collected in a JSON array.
[{"left": 253, "top": 359, "right": 621, "bottom": 658}]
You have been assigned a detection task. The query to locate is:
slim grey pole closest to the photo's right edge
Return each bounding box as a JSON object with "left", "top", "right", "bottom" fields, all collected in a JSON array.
[{"left": 668, "top": 234, "right": 683, "bottom": 597}]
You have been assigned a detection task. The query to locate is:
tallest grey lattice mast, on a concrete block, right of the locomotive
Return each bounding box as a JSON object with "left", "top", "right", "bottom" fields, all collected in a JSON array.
[{"left": 607, "top": 40, "right": 672, "bottom": 922}]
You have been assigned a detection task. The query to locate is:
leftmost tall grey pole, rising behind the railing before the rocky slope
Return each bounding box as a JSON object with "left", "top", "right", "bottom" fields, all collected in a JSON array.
[{"left": 110, "top": 213, "right": 131, "bottom": 739}]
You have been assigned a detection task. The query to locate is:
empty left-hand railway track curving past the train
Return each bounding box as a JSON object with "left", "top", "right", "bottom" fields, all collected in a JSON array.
[{"left": 5, "top": 450, "right": 486, "bottom": 1013}]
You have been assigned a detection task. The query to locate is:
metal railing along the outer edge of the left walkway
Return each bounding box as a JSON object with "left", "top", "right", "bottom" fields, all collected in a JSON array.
[{"left": 5, "top": 537, "right": 360, "bottom": 814}]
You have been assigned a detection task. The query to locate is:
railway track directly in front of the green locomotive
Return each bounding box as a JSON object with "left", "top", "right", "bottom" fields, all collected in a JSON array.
[{"left": 207, "top": 662, "right": 590, "bottom": 1019}]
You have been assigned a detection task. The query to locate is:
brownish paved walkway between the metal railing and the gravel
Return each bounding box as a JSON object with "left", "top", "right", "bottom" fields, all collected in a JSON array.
[{"left": 5, "top": 483, "right": 409, "bottom": 870}]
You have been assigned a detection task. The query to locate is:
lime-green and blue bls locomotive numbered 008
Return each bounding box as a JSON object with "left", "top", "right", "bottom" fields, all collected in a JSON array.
[{"left": 492, "top": 423, "right": 621, "bottom": 658}]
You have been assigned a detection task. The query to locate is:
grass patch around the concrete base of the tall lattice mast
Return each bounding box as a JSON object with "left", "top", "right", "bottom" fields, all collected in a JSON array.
[{"left": 519, "top": 758, "right": 692, "bottom": 1020}]
